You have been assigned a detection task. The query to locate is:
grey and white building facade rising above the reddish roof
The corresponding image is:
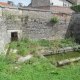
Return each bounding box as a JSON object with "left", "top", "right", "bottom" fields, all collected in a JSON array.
[{"left": 31, "top": 0, "right": 73, "bottom": 7}]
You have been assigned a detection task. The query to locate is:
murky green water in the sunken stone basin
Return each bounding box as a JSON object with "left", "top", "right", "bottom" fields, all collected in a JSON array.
[{"left": 45, "top": 52, "right": 80, "bottom": 63}]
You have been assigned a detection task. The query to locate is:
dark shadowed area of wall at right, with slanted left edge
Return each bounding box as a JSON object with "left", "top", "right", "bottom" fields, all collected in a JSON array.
[{"left": 65, "top": 13, "right": 80, "bottom": 44}]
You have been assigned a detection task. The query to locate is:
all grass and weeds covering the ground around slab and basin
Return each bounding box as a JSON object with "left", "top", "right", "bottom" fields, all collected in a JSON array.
[{"left": 0, "top": 38, "right": 80, "bottom": 80}]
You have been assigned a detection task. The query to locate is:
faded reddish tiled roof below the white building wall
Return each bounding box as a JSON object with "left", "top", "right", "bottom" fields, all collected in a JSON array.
[{"left": 50, "top": 6, "right": 74, "bottom": 13}]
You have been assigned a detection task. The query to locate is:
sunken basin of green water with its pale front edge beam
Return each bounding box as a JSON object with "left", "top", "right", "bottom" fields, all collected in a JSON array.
[{"left": 45, "top": 52, "right": 80, "bottom": 66}]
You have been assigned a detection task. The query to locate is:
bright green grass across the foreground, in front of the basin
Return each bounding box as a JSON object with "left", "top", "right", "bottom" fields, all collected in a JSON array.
[{"left": 0, "top": 53, "right": 80, "bottom": 80}]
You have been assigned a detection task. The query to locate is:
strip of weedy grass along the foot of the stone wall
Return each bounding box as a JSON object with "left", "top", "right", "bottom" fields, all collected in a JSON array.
[{"left": 10, "top": 38, "right": 78, "bottom": 56}]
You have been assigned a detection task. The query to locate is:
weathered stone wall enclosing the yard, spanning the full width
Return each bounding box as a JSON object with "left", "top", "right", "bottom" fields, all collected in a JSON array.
[{"left": 0, "top": 8, "right": 80, "bottom": 52}]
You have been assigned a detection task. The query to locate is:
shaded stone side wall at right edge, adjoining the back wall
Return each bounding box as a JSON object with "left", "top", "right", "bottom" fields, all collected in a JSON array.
[{"left": 69, "top": 13, "right": 80, "bottom": 43}]
